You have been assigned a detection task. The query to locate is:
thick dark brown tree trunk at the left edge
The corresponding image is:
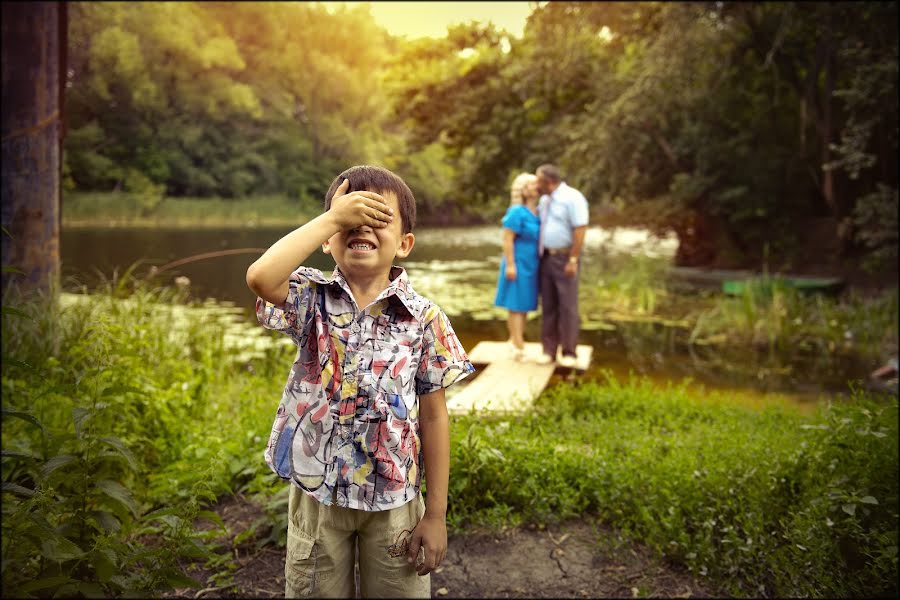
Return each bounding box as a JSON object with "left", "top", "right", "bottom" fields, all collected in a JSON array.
[{"left": 0, "top": 2, "right": 67, "bottom": 292}]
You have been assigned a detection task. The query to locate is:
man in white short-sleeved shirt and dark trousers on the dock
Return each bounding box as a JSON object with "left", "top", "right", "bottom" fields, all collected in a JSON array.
[{"left": 537, "top": 164, "right": 588, "bottom": 368}]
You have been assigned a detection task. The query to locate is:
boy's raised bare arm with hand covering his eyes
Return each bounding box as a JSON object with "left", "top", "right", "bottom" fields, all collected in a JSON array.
[{"left": 247, "top": 179, "right": 393, "bottom": 305}]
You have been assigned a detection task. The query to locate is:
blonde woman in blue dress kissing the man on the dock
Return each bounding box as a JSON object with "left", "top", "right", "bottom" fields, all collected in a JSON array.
[{"left": 494, "top": 173, "right": 541, "bottom": 360}]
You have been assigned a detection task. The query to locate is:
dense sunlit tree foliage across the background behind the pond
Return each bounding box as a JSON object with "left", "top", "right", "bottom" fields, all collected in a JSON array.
[{"left": 66, "top": 2, "right": 898, "bottom": 267}]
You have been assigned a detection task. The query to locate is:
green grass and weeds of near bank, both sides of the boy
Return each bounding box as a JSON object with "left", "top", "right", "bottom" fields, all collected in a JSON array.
[{"left": 2, "top": 276, "right": 898, "bottom": 597}]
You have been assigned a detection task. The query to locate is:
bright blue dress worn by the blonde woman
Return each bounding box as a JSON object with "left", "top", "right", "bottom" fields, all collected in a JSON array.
[{"left": 494, "top": 204, "right": 541, "bottom": 312}]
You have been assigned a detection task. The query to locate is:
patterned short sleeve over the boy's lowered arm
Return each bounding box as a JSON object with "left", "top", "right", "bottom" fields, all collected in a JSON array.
[{"left": 416, "top": 306, "right": 475, "bottom": 395}]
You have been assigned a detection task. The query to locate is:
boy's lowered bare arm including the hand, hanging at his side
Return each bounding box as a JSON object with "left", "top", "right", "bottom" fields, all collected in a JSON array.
[{"left": 409, "top": 388, "right": 450, "bottom": 575}]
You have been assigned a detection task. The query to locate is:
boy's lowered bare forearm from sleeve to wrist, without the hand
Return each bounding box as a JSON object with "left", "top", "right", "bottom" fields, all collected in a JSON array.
[{"left": 419, "top": 390, "right": 450, "bottom": 520}]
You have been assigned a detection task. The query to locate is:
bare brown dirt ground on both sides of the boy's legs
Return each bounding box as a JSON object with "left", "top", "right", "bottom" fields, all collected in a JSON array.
[{"left": 163, "top": 497, "right": 718, "bottom": 598}]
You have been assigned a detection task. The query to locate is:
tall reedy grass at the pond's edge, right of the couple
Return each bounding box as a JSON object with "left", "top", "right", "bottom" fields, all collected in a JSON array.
[{"left": 579, "top": 256, "right": 900, "bottom": 368}]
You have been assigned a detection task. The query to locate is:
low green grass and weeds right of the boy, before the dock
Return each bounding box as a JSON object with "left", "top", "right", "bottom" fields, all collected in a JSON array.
[{"left": 449, "top": 376, "right": 898, "bottom": 597}]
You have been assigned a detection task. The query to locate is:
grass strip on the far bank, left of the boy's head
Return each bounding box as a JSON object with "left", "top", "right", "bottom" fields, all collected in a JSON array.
[{"left": 62, "top": 192, "right": 321, "bottom": 227}]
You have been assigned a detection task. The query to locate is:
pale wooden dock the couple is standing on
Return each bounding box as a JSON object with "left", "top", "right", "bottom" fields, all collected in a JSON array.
[{"left": 447, "top": 342, "right": 594, "bottom": 414}]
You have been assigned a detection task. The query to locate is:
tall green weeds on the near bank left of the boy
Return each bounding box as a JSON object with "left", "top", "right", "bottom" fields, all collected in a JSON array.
[{"left": 2, "top": 274, "right": 289, "bottom": 597}]
